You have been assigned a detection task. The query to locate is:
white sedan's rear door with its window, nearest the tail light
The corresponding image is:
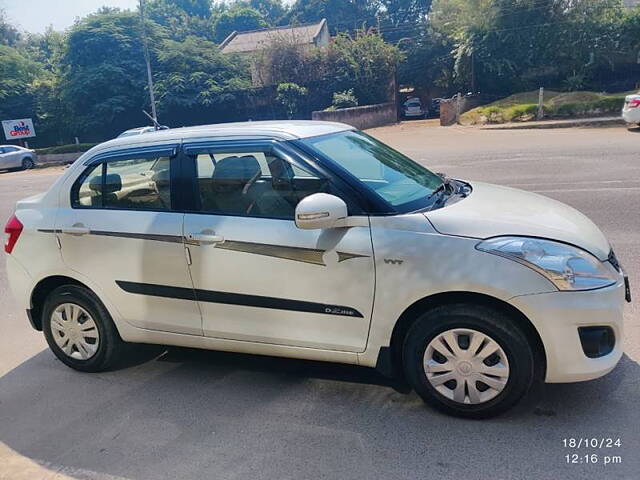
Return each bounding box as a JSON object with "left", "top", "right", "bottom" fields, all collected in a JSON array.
[{"left": 56, "top": 145, "right": 202, "bottom": 335}]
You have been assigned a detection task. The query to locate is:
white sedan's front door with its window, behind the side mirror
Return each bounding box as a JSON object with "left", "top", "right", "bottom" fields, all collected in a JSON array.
[{"left": 184, "top": 143, "right": 375, "bottom": 352}]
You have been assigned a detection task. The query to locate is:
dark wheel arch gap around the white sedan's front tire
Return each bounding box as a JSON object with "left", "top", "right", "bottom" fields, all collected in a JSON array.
[{"left": 376, "top": 292, "right": 547, "bottom": 386}]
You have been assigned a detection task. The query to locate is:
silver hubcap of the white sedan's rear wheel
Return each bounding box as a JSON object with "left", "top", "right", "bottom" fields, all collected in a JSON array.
[{"left": 51, "top": 303, "right": 100, "bottom": 360}]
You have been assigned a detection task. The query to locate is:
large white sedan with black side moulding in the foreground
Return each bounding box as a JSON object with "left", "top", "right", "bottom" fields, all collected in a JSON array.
[{"left": 5, "top": 121, "right": 630, "bottom": 417}]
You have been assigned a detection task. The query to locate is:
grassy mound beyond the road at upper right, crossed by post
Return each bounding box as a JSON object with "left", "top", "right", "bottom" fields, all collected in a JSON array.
[{"left": 460, "top": 90, "right": 629, "bottom": 125}]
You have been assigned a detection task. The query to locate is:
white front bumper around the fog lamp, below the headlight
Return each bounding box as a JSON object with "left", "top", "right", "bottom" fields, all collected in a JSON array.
[{"left": 510, "top": 279, "right": 625, "bottom": 383}]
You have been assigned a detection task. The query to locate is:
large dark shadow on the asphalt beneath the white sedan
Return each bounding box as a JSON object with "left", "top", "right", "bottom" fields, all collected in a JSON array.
[{"left": 0, "top": 349, "right": 640, "bottom": 480}]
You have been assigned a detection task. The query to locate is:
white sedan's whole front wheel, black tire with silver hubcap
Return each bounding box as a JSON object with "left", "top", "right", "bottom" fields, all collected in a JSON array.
[{"left": 403, "top": 304, "right": 535, "bottom": 418}]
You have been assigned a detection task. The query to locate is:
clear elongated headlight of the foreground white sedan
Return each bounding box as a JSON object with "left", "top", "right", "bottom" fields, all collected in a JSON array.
[{"left": 476, "top": 237, "right": 618, "bottom": 290}]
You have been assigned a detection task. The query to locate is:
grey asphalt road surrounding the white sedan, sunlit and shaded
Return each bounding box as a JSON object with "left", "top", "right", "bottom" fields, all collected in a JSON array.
[{"left": 0, "top": 122, "right": 640, "bottom": 480}]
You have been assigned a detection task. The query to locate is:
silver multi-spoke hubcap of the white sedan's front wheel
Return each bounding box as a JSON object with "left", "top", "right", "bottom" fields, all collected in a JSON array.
[{"left": 424, "top": 328, "right": 509, "bottom": 405}]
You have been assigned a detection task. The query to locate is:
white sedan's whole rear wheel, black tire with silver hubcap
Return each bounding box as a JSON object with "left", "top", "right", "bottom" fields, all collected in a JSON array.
[{"left": 42, "top": 285, "right": 127, "bottom": 372}]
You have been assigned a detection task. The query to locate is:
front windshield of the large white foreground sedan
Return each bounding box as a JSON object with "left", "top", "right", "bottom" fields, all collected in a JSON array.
[{"left": 302, "top": 131, "right": 442, "bottom": 213}]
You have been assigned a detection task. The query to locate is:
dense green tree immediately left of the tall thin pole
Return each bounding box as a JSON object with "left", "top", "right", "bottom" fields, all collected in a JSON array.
[{"left": 60, "top": 12, "right": 159, "bottom": 140}]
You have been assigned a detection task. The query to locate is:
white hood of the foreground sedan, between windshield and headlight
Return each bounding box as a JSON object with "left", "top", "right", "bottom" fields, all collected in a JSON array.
[{"left": 425, "top": 182, "right": 611, "bottom": 260}]
